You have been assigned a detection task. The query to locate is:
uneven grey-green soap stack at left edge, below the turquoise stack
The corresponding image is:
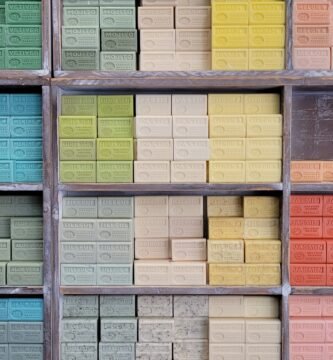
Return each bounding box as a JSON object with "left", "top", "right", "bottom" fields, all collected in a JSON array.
[{"left": 0, "top": 195, "right": 43, "bottom": 286}]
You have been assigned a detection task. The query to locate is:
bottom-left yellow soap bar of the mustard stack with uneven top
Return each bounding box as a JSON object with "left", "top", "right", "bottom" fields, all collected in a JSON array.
[{"left": 209, "top": 264, "right": 245, "bottom": 286}]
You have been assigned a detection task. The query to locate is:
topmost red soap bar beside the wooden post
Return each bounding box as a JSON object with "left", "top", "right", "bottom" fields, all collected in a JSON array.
[{"left": 290, "top": 195, "right": 323, "bottom": 216}]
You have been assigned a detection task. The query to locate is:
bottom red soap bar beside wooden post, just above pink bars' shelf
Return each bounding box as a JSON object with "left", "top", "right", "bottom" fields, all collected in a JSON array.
[{"left": 290, "top": 264, "right": 326, "bottom": 286}]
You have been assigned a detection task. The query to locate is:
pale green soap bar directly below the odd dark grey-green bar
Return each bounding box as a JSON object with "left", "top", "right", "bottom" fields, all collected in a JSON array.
[{"left": 100, "top": 51, "right": 136, "bottom": 71}]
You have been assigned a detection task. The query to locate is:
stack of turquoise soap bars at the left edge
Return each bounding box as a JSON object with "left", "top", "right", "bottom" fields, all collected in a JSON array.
[{"left": 0, "top": 93, "right": 43, "bottom": 183}]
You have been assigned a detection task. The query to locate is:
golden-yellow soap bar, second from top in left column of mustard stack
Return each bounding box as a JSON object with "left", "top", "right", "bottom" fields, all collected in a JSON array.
[{"left": 208, "top": 217, "right": 244, "bottom": 240}]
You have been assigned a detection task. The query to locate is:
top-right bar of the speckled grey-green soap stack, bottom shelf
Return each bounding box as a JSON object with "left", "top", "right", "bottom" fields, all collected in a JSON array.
[{"left": 99, "top": 295, "right": 135, "bottom": 317}]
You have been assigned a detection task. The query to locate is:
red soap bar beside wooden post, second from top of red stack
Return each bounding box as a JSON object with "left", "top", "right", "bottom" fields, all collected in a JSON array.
[{"left": 290, "top": 217, "right": 323, "bottom": 239}]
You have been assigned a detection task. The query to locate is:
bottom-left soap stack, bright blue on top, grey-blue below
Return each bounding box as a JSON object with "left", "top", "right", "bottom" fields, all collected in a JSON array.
[{"left": 0, "top": 298, "right": 44, "bottom": 360}]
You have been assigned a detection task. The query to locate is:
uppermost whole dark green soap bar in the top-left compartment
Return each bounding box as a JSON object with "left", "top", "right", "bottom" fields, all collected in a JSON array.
[{"left": 6, "top": 1, "right": 42, "bottom": 25}]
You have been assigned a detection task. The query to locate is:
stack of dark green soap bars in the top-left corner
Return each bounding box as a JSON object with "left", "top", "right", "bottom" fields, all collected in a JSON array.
[{"left": 0, "top": 1, "right": 42, "bottom": 70}]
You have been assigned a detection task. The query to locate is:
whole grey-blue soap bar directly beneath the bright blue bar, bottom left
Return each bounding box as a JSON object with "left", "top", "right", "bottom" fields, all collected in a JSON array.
[{"left": 8, "top": 321, "right": 44, "bottom": 344}]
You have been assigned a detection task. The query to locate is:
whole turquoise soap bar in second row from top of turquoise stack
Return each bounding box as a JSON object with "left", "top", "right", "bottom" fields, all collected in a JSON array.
[{"left": 9, "top": 116, "right": 43, "bottom": 138}]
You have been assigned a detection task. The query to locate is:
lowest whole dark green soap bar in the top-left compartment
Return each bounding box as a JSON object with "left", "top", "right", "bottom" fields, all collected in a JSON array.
[{"left": 5, "top": 48, "right": 42, "bottom": 70}]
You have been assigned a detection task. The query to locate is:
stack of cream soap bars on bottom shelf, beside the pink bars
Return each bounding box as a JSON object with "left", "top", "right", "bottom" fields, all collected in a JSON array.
[{"left": 209, "top": 296, "right": 281, "bottom": 360}]
